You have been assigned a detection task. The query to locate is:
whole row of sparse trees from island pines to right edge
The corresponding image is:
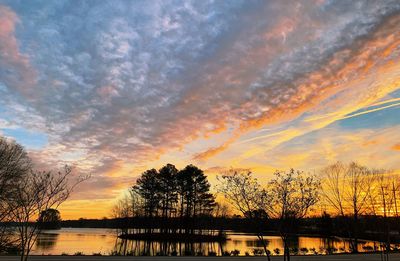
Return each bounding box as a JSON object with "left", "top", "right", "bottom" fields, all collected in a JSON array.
[{"left": 218, "top": 162, "right": 400, "bottom": 260}]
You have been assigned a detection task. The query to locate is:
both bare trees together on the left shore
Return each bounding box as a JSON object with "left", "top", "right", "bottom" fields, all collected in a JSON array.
[{"left": 0, "top": 137, "right": 88, "bottom": 260}]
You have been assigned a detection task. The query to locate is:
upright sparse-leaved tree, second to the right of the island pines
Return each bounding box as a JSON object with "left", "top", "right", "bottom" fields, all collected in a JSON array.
[{"left": 268, "top": 169, "right": 320, "bottom": 261}]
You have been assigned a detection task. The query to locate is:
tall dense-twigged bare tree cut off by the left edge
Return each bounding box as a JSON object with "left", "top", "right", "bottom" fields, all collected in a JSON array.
[{"left": 0, "top": 137, "right": 31, "bottom": 252}]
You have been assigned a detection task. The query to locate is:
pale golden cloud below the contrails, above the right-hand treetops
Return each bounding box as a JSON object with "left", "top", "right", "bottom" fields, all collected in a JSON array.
[{"left": 266, "top": 126, "right": 400, "bottom": 171}]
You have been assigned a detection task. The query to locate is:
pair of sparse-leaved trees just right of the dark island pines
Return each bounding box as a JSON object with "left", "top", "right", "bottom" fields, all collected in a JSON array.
[{"left": 218, "top": 169, "right": 320, "bottom": 260}]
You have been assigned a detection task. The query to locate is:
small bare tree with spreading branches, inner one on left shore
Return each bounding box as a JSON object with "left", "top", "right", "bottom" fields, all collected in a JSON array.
[{"left": 6, "top": 166, "right": 88, "bottom": 261}]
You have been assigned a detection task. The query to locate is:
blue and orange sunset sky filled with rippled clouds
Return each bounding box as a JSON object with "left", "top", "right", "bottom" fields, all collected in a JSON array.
[{"left": 0, "top": 0, "right": 400, "bottom": 219}]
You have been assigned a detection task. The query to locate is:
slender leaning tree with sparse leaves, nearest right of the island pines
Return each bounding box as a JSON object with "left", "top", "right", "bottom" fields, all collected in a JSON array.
[{"left": 217, "top": 169, "right": 271, "bottom": 260}]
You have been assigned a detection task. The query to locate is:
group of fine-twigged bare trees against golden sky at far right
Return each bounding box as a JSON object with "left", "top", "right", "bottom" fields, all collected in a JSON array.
[{"left": 321, "top": 162, "right": 400, "bottom": 260}]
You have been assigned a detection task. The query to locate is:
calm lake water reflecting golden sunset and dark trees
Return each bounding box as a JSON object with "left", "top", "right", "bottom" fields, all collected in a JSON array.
[{"left": 33, "top": 228, "right": 388, "bottom": 255}]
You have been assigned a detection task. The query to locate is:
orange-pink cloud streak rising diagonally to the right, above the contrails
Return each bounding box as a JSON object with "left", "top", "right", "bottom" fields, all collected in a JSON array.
[{"left": 195, "top": 16, "right": 400, "bottom": 160}]
